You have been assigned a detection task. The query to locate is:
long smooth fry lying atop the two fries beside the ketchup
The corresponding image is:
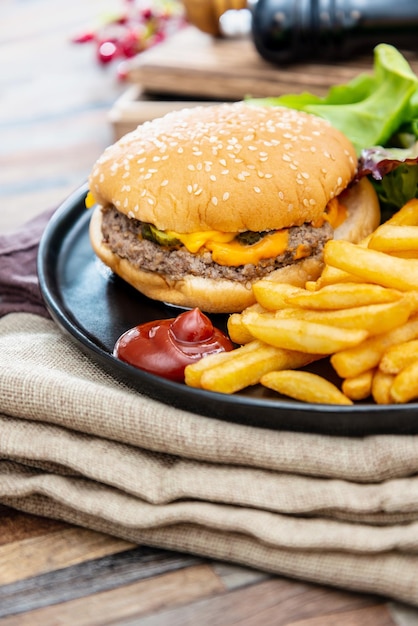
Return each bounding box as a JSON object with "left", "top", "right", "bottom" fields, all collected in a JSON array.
[{"left": 244, "top": 313, "right": 368, "bottom": 355}]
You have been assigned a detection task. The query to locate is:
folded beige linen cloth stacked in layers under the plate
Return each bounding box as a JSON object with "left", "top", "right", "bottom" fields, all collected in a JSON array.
[{"left": 0, "top": 313, "right": 418, "bottom": 605}]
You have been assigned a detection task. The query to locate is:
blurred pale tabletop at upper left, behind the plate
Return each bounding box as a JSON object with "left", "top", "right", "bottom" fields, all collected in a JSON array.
[{"left": 0, "top": 0, "right": 131, "bottom": 232}]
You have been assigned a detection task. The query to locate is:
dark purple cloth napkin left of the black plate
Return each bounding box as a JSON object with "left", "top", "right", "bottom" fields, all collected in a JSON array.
[{"left": 0, "top": 211, "right": 54, "bottom": 317}]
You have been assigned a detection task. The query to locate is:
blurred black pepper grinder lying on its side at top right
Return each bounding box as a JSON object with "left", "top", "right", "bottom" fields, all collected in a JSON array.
[{"left": 250, "top": 0, "right": 418, "bottom": 65}]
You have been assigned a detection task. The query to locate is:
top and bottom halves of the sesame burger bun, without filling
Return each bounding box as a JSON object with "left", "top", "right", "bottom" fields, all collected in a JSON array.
[{"left": 89, "top": 102, "right": 380, "bottom": 313}]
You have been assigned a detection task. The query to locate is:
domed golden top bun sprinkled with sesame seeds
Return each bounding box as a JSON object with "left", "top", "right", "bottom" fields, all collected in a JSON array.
[{"left": 90, "top": 102, "right": 357, "bottom": 233}]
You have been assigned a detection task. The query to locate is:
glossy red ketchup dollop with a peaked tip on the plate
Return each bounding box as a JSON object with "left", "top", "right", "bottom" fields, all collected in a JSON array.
[{"left": 113, "top": 308, "right": 233, "bottom": 382}]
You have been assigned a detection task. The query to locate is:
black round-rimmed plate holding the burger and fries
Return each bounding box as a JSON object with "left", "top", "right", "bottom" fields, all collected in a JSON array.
[{"left": 38, "top": 185, "right": 418, "bottom": 436}]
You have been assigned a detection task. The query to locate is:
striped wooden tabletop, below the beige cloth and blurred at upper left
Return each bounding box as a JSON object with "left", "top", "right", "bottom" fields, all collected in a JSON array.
[{"left": 0, "top": 0, "right": 418, "bottom": 626}]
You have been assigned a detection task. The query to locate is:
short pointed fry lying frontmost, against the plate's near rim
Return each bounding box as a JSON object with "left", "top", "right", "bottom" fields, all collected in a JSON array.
[{"left": 260, "top": 370, "right": 353, "bottom": 404}]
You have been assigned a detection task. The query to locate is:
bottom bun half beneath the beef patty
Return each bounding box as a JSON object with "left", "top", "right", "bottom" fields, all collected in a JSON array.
[{"left": 90, "top": 178, "right": 380, "bottom": 313}]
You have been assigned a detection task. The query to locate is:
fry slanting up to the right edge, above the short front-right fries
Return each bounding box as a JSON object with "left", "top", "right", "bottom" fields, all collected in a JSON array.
[{"left": 331, "top": 316, "right": 418, "bottom": 378}]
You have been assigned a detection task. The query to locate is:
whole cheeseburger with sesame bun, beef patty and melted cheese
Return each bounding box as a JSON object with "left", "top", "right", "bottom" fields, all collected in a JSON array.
[{"left": 87, "top": 102, "right": 380, "bottom": 313}]
